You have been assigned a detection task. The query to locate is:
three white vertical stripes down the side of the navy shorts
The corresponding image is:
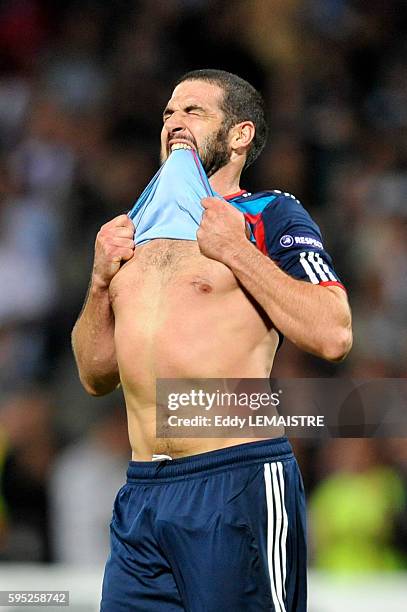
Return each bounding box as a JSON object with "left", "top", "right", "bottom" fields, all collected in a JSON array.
[{"left": 264, "top": 462, "right": 288, "bottom": 612}]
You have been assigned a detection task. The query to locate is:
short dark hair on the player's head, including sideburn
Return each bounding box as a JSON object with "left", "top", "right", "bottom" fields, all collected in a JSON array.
[{"left": 175, "top": 68, "right": 268, "bottom": 168}]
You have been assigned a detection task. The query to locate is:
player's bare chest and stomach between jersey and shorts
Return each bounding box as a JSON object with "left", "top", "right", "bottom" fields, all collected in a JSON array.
[{"left": 110, "top": 239, "right": 278, "bottom": 460}]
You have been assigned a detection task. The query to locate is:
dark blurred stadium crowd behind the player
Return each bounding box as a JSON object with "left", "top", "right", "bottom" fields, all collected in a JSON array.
[{"left": 0, "top": 0, "right": 407, "bottom": 574}]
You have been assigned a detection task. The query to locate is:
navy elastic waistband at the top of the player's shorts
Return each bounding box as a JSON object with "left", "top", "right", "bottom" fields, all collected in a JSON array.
[{"left": 127, "top": 437, "right": 293, "bottom": 483}]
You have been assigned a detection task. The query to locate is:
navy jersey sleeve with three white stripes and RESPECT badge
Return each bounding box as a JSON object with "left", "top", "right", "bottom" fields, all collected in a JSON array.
[{"left": 262, "top": 193, "right": 343, "bottom": 287}]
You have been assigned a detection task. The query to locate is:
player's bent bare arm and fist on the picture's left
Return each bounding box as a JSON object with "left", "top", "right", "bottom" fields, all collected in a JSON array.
[{"left": 72, "top": 215, "right": 134, "bottom": 395}]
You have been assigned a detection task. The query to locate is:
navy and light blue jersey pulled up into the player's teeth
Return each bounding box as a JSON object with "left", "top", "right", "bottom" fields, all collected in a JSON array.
[{"left": 129, "top": 149, "right": 343, "bottom": 288}]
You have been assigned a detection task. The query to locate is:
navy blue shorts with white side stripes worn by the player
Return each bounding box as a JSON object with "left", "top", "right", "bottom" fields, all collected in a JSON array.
[{"left": 101, "top": 438, "right": 307, "bottom": 612}]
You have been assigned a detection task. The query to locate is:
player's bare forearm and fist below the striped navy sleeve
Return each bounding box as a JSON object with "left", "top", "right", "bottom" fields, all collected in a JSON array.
[{"left": 197, "top": 198, "right": 352, "bottom": 361}]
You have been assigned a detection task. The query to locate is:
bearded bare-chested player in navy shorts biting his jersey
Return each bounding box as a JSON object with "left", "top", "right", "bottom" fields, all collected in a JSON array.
[{"left": 73, "top": 70, "right": 352, "bottom": 612}]
